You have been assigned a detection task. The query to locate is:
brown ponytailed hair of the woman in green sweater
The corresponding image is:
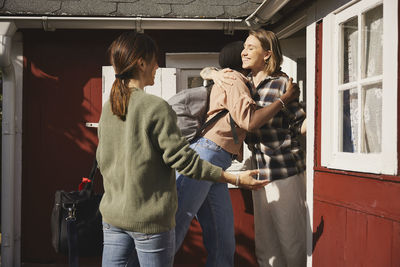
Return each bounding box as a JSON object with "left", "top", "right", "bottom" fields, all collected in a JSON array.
[{"left": 109, "top": 31, "right": 158, "bottom": 120}]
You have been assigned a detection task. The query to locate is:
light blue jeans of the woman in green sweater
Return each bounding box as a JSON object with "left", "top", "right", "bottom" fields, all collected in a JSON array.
[{"left": 102, "top": 222, "right": 175, "bottom": 267}]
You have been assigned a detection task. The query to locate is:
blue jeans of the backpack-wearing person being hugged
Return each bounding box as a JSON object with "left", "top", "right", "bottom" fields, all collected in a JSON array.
[{"left": 175, "top": 137, "right": 235, "bottom": 267}]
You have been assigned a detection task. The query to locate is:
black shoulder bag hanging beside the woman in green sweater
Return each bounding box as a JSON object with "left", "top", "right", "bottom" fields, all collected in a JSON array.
[{"left": 51, "top": 160, "right": 103, "bottom": 267}]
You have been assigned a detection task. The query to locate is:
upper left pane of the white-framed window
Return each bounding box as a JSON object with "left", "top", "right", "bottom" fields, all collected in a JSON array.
[{"left": 341, "top": 17, "right": 358, "bottom": 83}]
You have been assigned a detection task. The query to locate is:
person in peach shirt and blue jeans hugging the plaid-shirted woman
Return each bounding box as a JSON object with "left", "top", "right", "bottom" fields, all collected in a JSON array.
[{"left": 175, "top": 41, "right": 299, "bottom": 267}]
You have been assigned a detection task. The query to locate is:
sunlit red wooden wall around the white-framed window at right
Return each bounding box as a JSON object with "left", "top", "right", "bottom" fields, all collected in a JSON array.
[{"left": 313, "top": 15, "right": 400, "bottom": 267}]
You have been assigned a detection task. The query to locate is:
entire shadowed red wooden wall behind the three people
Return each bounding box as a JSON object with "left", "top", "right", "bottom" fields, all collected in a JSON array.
[{"left": 21, "top": 30, "right": 256, "bottom": 267}]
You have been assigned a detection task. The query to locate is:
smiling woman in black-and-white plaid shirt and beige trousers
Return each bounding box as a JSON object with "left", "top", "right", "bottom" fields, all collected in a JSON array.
[{"left": 206, "top": 29, "right": 306, "bottom": 267}]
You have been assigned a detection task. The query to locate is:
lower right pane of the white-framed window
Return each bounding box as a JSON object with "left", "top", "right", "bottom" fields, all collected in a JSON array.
[{"left": 362, "top": 83, "right": 382, "bottom": 153}]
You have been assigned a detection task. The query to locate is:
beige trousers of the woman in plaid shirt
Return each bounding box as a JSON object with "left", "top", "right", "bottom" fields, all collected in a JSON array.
[{"left": 253, "top": 173, "right": 307, "bottom": 267}]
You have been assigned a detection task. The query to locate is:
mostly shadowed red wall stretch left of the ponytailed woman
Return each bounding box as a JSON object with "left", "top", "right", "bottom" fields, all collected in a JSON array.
[{"left": 21, "top": 30, "right": 114, "bottom": 264}]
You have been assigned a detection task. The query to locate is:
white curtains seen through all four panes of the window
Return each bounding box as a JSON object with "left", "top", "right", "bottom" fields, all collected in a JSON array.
[{"left": 342, "top": 5, "right": 383, "bottom": 153}]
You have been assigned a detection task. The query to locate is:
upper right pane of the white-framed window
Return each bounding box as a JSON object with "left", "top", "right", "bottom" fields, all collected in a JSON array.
[{"left": 363, "top": 5, "right": 383, "bottom": 78}]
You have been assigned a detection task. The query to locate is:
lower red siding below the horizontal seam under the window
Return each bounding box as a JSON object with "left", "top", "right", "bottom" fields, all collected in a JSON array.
[{"left": 313, "top": 197, "right": 400, "bottom": 267}]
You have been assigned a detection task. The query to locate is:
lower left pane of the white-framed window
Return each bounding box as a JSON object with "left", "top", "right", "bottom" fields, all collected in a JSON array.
[{"left": 339, "top": 88, "right": 359, "bottom": 152}]
